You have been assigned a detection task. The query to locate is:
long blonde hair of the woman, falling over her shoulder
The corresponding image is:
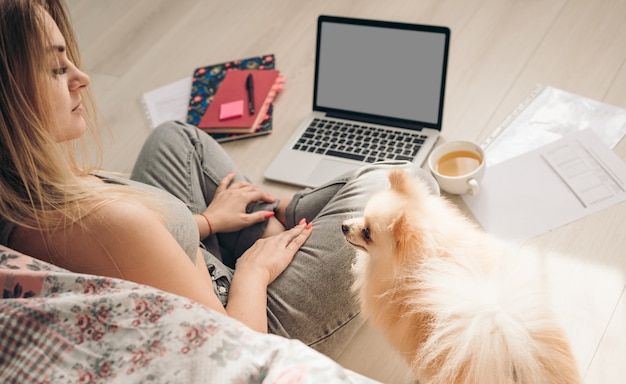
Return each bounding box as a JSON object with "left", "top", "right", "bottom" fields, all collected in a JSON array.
[{"left": 0, "top": 0, "right": 150, "bottom": 233}]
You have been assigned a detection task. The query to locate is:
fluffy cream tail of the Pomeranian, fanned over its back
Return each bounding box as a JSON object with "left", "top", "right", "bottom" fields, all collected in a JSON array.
[{"left": 413, "top": 254, "right": 581, "bottom": 384}]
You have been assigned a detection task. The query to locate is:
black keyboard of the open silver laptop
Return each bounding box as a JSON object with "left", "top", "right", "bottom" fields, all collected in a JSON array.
[{"left": 293, "top": 118, "right": 427, "bottom": 163}]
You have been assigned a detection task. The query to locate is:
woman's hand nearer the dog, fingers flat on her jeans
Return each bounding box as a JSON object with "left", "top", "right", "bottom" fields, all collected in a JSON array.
[{"left": 235, "top": 219, "right": 313, "bottom": 286}]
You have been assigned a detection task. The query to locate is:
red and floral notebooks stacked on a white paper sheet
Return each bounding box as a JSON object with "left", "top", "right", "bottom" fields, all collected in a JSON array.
[{"left": 140, "top": 54, "right": 285, "bottom": 142}]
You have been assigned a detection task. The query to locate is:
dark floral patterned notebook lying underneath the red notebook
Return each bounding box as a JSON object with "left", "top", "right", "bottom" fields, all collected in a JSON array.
[{"left": 187, "top": 54, "right": 276, "bottom": 142}]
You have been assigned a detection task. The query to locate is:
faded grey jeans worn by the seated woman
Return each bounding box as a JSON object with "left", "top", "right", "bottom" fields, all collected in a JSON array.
[{"left": 131, "top": 122, "right": 438, "bottom": 357}]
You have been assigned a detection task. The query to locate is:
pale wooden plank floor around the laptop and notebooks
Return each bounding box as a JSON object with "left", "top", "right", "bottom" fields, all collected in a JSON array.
[{"left": 69, "top": 0, "right": 626, "bottom": 383}]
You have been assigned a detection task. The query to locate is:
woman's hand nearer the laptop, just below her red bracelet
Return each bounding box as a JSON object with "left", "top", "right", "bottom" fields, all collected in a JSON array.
[{"left": 203, "top": 171, "right": 276, "bottom": 233}]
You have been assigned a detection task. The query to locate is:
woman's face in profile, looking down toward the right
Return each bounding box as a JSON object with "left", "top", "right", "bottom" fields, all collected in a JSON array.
[{"left": 45, "top": 12, "right": 90, "bottom": 142}]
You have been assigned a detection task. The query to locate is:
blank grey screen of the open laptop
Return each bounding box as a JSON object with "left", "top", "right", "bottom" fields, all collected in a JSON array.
[{"left": 314, "top": 21, "right": 449, "bottom": 127}]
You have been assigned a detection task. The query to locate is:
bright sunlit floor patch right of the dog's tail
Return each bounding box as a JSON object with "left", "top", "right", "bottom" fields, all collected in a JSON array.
[{"left": 546, "top": 254, "right": 626, "bottom": 383}]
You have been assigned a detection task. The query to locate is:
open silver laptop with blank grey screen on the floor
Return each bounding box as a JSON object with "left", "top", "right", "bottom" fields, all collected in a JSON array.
[{"left": 264, "top": 15, "right": 450, "bottom": 187}]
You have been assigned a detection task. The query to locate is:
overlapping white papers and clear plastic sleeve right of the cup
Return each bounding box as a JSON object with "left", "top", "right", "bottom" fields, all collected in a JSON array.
[{"left": 463, "top": 87, "right": 626, "bottom": 241}]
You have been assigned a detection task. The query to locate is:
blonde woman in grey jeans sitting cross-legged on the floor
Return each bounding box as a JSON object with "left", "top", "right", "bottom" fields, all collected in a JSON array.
[{"left": 0, "top": 0, "right": 434, "bottom": 355}]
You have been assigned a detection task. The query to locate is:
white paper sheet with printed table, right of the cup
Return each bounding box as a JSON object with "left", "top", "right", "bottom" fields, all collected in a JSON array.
[{"left": 463, "top": 129, "right": 626, "bottom": 241}]
